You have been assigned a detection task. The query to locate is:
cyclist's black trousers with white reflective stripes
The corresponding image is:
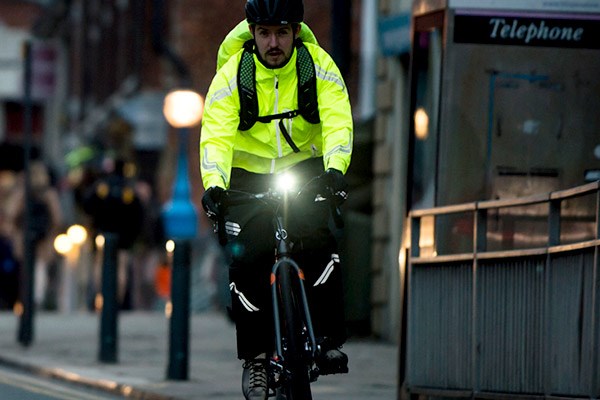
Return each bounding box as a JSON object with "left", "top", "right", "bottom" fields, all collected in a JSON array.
[{"left": 226, "top": 159, "right": 346, "bottom": 359}]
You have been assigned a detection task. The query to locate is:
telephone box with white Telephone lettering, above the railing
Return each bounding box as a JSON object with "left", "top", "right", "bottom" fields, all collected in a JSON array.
[{"left": 408, "top": 0, "right": 600, "bottom": 250}]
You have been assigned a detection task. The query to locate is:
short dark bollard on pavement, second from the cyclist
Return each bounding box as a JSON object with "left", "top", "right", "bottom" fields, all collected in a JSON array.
[{"left": 98, "top": 233, "right": 119, "bottom": 363}]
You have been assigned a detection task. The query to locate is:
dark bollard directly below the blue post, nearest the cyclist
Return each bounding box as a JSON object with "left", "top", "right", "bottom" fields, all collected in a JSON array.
[{"left": 167, "top": 240, "right": 191, "bottom": 380}]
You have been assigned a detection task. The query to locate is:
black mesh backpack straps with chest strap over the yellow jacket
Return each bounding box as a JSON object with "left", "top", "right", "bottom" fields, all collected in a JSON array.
[{"left": 238, "top": 39, "right": 321, "bottom": 130}]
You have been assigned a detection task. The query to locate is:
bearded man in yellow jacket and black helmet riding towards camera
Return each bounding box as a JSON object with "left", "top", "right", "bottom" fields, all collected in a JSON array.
[{"left": 200, "top": 0, "right": 353, "bottom": 400}]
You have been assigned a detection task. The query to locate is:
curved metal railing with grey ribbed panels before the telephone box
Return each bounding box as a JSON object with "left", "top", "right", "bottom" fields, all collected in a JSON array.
[{"left": 400, "top": 182, "right": 600, "bottom": 399}]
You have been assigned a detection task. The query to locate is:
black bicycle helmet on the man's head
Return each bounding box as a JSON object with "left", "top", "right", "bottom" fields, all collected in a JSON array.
[{"left": 246, "top": 0, "right": 304, "bottom": 25}]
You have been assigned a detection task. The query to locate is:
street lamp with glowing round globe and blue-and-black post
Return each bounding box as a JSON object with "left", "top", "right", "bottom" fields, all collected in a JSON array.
[{"left": 163, "top": 90, "right": 204, "bottom": 380}]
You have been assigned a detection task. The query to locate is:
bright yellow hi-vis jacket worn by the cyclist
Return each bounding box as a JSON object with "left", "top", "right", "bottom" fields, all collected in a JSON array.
[{"left": 200, "top": 36, "right": 353, "bottom": 189}]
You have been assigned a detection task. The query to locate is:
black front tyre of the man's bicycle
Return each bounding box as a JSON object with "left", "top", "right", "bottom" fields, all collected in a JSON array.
[{"left": 279, "top": 265, "right": 312, "bottom": 400}]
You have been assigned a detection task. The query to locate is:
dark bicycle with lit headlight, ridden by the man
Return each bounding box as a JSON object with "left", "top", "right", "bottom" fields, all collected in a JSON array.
[{"left": 215, "top": 173, "right": 343, "bottom": 400}]
